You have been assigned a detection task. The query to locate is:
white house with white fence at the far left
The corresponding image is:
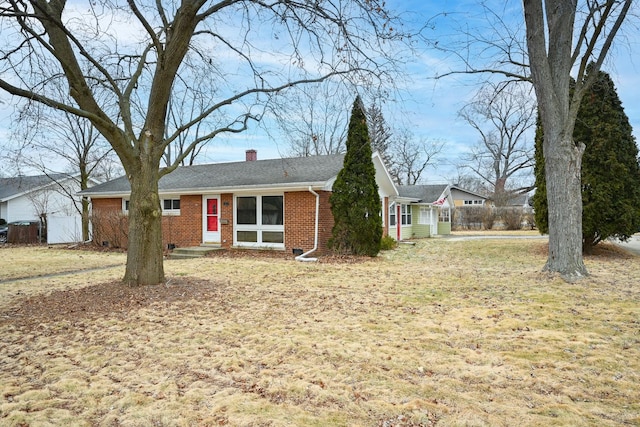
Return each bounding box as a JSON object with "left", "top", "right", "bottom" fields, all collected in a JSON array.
[{"left": 0, "top": 174, "right": 96, "bottom": 244}]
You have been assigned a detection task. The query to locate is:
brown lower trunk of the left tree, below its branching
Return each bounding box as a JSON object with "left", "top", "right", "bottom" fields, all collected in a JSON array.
[{"left": 123, "top": 164, "right": 164, "bottom": 286}]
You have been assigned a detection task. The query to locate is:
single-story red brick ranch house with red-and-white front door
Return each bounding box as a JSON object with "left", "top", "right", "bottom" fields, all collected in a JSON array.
[{"left": 81, "top": 150, "right": 398, "bottom": 253}]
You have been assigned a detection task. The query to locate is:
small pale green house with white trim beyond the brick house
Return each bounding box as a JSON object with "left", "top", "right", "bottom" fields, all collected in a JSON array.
[{"left": 389, "top": 184, "right": 452, "bottom": 240}]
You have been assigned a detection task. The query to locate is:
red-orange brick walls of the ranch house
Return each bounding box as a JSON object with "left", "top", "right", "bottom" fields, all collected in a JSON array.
[{"left": 92, "top": 191, "right": 389, "bottom": 253}]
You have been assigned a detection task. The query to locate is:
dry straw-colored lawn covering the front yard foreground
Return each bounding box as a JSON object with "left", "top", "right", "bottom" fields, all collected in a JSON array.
[{"left": 0, "top": 239, "right": 640, "bottom": 426}]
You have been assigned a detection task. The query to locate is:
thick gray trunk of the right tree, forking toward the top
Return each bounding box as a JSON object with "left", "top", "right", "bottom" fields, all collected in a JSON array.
[{"left": 523, "top": 0, "right": 588, "bottom": 281}]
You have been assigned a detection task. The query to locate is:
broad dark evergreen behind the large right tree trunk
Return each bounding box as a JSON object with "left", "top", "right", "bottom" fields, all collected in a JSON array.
[{"left": 534, "top": 71, "right": 640, "bottom": 252}]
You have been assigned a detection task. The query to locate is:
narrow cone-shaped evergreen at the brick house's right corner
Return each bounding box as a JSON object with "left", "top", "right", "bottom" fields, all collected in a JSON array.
[{"left": 329, "top": 96, "right": 382, "bottom": 256}]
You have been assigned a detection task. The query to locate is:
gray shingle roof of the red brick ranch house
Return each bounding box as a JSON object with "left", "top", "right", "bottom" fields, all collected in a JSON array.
[{"left": 81, "top": 154, "right": 344, "bottom": 195}]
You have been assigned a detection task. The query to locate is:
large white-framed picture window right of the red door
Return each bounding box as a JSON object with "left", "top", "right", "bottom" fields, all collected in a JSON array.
[{"left": 235, "top": 196, "right": 284, "bottom": 247}]
